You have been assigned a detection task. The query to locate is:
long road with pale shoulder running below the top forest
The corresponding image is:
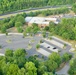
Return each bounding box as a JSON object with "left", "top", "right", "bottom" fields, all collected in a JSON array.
[{"left": 0, "top": 5, "right": 71, "bottom": 20}]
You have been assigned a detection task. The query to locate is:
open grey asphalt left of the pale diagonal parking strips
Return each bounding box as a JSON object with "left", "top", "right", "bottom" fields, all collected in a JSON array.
[{"left": 0, "top": 35, "right": 42, "bottom": 56}]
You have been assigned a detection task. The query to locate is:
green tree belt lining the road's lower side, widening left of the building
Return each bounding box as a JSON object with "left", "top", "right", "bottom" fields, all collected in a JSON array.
[{"left": 0, "top": 7, "right": 69, "bottom": 33}]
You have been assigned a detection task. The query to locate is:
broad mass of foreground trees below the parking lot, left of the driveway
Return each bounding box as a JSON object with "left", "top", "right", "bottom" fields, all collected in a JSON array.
[{"left": 0, "top": 49, "right": 72, "bottom": 75}]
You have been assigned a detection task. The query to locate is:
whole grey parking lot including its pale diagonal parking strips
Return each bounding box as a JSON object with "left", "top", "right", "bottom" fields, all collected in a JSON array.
[{"left": 0, "top": 34, "right": 71, "bottom": 57}]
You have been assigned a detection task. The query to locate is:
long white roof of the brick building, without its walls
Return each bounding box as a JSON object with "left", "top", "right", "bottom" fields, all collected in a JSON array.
[{"left": 25, "top": 17, "right": 57, "bottom": 24}]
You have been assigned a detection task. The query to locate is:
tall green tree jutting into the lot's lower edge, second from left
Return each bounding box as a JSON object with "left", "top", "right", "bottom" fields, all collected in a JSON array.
[{"left": 13, "top": 49, "right": 26, "bottom": 68}]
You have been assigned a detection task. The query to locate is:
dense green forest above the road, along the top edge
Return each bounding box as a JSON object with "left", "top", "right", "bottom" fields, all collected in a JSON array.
[{"left": 0, "top": 0, "right": 76, "bottom": 14}]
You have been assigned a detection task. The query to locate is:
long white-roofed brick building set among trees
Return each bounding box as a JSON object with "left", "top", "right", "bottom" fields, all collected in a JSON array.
[{"left": 25, "top": 17, "right": 59, "bottom": 28}]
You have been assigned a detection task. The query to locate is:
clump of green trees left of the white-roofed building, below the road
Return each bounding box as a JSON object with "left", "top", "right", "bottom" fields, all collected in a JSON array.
[{"left": 0, "top": 14, "right": 25, "bottom": 33}]
